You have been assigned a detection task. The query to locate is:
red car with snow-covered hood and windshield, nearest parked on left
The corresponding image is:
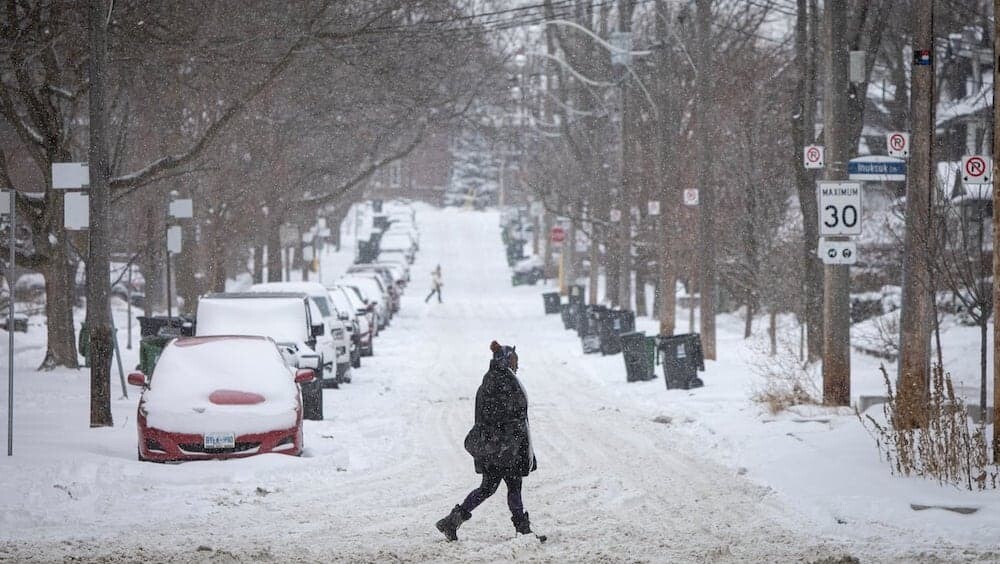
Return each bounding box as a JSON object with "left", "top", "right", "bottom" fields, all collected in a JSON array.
[{"left": 128, "top": 336, "right": 315, "bottom": 462}]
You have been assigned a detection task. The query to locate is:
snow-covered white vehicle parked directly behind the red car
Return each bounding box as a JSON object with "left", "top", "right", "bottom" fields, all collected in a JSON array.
[{"left": 195, "top": 292, "right": 328, "bottom": 420}]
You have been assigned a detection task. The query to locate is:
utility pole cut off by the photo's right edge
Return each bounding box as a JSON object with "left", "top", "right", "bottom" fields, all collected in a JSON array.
[{"left": 984, "top": 0, "right": 1000, "bottom": 462}]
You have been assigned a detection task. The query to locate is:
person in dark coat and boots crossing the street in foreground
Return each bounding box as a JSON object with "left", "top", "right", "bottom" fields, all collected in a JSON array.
[{"left": 437, "top": 341, "right": 545, "bottom": 541}]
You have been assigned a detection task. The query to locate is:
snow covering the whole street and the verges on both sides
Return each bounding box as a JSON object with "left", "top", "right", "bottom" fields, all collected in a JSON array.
[{"left": 0, "top": 208, "right": 1000, "bottom": 562}]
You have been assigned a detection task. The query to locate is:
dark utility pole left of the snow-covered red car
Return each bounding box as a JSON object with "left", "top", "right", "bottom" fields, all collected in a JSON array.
[{"left": 87, "top": 0, "right": 115, "bottom": 427}]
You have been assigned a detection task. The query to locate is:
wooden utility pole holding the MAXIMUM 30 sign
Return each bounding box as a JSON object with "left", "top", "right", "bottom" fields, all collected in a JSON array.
[{"left": 823, "top": 0, "right": 852, "bottom": 405}]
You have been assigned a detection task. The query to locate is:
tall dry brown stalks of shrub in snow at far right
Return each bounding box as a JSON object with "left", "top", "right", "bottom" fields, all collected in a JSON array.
[{"left": 858, "top": 366, "right": 1000, "bottom": 490}]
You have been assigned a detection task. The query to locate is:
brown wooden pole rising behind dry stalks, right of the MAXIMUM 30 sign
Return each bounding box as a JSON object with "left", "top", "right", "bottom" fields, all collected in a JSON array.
[{"left": 897, "top": 0, "right": 934, "bottom": 428}]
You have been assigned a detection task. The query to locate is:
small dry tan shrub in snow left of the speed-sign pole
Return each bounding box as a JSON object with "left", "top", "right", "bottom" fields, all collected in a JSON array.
[{"left": 750, "top": 330, "right": 823, "bottom": 415}]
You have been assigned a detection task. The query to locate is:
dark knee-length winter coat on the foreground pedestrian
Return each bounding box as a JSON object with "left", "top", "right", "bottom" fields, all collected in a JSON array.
[{"left": 465, "top": 362, "right": 538, "bottom": 476}]
